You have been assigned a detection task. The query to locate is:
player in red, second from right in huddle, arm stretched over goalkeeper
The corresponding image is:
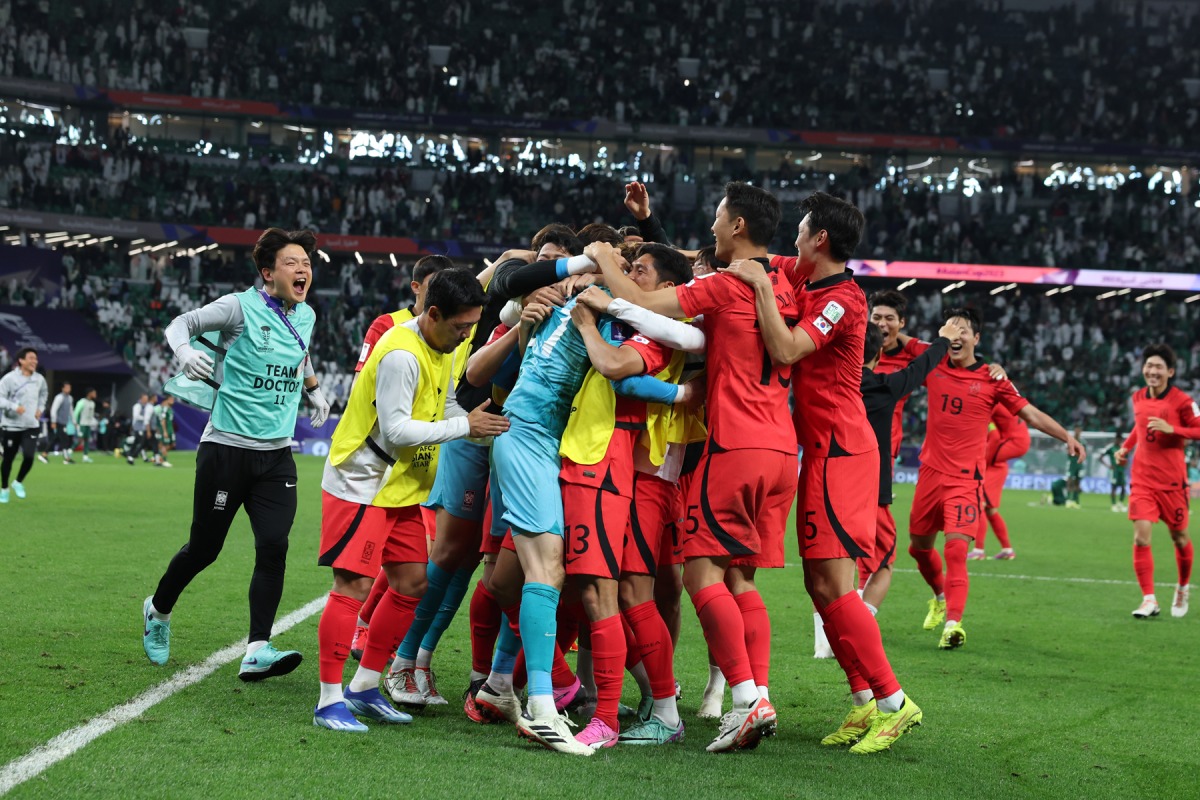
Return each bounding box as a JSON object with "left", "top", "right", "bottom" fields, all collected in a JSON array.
[{"left": 590, "top": 181, "right": 796, "bottom": 752}]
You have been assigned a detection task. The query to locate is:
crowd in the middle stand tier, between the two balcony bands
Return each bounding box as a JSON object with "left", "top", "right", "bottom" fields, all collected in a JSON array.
[{"left": 0, "top": 137, "right": 1200, "bottom": 275}]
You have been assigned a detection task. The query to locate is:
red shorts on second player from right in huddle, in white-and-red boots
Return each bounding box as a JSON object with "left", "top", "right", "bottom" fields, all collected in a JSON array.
[{"left": 683, "top": 450, "right": 796, "bottom": 569}]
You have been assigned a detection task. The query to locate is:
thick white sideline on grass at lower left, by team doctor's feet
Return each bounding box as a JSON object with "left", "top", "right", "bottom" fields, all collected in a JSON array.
[{"left": 0, "top": 595, "right": 325, "bottom": 794}]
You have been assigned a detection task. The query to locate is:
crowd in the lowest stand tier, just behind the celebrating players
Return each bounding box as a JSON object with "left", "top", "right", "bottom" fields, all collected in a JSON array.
[{"left": 0, "top": 220, "right": 1200, "bottom": 441}]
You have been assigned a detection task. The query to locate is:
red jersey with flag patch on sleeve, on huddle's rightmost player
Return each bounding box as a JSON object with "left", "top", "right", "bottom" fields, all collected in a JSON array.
[{"left": 792, "top": 270, "right": 880, "bottom": 458}]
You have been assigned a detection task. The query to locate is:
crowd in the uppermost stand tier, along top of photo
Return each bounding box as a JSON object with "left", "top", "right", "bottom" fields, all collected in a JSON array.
[{"left": 0, "top": 0, "right": 1200, "bottom": 146}]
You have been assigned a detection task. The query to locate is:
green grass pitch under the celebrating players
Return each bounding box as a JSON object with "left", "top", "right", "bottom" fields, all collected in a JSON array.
[{"left": 0, "top": 453, "right": 1200, "bottom": 799}]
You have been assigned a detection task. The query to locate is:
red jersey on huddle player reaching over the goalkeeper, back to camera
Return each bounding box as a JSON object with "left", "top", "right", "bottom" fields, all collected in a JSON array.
[{"left": 676, "top": 259, "right": 797, "bottom": 456}]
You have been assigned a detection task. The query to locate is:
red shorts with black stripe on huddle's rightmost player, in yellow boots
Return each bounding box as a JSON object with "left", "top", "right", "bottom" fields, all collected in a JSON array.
[{"left": 796, "top": 450, "right": 880, "bottom": 559}]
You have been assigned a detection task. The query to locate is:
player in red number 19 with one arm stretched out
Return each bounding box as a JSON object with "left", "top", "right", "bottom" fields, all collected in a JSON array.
[{"left": 908, "top": 308, "right": 1086, "bottom": 650}]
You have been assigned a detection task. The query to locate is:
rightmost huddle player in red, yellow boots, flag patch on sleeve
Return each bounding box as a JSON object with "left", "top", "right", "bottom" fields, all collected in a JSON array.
[{"left": 727, "top": 192, "right": 922, "bottom": 753}]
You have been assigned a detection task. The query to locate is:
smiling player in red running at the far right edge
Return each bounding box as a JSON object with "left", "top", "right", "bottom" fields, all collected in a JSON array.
[{"left": 1114, "top": 344, "right": 1200, "bottom": 619}]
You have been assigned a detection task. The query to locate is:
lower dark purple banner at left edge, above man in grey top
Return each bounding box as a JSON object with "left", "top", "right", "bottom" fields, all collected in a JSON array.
[{"left": 0, "top": 306, "right": 133, "bottom": 375}]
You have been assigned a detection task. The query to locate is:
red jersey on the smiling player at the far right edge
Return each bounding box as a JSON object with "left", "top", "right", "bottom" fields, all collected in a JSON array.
[{"left": 1121, "top": 386, "right": 1200, "bottom": 489}]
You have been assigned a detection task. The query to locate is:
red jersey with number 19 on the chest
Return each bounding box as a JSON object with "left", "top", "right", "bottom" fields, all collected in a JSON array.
[{"left": 920, "top": 356, "right": 1030, "bottom": 480}]
